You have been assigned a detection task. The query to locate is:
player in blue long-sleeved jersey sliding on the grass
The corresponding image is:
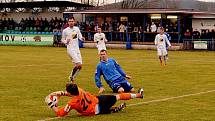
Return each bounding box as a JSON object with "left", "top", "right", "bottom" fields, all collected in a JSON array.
[{"left": 95, "top": 50, "right": 134, "bottom": 93}]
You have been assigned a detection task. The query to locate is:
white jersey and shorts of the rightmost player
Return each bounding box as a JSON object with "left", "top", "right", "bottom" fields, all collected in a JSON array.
[{"left": 155, "top": 34, "right": 171, "bottom": 55}]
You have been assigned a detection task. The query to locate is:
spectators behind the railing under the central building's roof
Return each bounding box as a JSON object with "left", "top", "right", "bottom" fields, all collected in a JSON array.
[{"left": 78, "top": 21, "right": 178, "bottom": 41}]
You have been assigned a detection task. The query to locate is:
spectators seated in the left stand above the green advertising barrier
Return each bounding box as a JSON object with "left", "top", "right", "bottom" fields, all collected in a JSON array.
[{"left": 0, "top": 17, "right": 66, "bottom": 32}]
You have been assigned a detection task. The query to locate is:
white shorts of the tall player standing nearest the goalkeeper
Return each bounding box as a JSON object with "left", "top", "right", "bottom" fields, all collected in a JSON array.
[{"left": 67, "top": 49, "right": 82, "bottom": 64}]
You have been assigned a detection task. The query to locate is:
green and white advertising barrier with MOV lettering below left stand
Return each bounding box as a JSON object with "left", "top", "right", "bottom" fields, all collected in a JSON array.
[{"left": 0, "top": 33, "right": 53, "bottom": 46}]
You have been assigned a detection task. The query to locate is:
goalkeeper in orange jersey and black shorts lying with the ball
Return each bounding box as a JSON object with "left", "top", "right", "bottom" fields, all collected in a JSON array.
[{"left": 45, "top": 83, "right": 143, "bottom": 117}]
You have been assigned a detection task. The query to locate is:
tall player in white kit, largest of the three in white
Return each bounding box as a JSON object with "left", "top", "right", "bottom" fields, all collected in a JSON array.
[{"left": 61, "top": 17, "right": 84, "bottom": 82}]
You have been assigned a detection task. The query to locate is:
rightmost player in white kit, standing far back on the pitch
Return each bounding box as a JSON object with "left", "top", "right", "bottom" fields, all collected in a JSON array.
[{"left": 155, "top": 27, "right": 171, "bottom": 65}]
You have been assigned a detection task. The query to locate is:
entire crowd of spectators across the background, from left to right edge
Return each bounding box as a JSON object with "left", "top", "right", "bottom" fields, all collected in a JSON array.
[{"left": 0, "top": 17, "right": 215, "bottom": 41}]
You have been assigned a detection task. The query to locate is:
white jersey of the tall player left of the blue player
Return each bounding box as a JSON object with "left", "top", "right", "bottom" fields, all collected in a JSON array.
[{"left": 61, "top": 26, "right": 82, "bottom": 51}]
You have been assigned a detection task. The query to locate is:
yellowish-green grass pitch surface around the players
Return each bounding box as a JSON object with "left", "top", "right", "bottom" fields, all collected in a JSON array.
[{"left": 0, "top": 46, "right": 215, "bottom": 121}]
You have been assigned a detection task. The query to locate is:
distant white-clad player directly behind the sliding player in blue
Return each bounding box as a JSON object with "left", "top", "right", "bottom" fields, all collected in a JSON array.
[{"left": 94, "top": 27, "right": 107, "bottom": 53}]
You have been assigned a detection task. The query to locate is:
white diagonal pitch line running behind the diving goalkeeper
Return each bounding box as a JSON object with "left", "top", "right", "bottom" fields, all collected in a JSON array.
[{"left": 37, "top": 90, "right": 215, "bottom": 121}]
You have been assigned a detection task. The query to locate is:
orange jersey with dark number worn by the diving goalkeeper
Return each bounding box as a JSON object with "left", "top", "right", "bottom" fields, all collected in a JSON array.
[{"left": 57, "top": 88, "right": 98, "bottom": 116}]
